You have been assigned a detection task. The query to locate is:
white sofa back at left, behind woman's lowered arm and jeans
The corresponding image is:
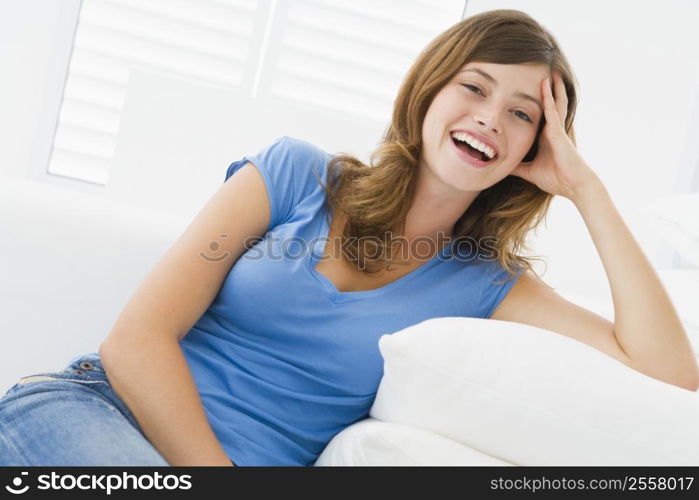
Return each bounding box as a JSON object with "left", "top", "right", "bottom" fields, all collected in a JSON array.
[{"left": 0, "top": 176, "right": 188, "bottom": 394}]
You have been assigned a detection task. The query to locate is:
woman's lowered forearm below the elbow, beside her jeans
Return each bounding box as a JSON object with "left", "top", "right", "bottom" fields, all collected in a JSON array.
[{"left": 100, "top": 332, "right": 233, "bottom": 466}]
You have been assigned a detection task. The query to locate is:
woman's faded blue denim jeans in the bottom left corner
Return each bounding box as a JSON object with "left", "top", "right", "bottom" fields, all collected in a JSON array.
[{"left": 0, "top": 353, "right": 169, "bottom": 466}]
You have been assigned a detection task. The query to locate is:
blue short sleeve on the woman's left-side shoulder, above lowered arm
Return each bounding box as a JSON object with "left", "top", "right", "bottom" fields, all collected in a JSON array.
[{"left": 224, "top": 136, "right": 332, "bottom": 230}]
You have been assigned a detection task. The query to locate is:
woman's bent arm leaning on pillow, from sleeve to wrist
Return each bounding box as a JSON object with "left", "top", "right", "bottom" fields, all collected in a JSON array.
[{"left": 491, "top": 181, "right": 699, "bottom": 391}]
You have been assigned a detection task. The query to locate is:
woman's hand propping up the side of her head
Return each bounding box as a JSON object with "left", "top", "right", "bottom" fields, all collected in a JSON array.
[{"left": 512, "top": 72, "right": 599, "bottom": 201}]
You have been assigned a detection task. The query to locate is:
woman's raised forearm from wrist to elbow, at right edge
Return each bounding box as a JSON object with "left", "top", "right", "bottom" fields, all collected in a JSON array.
[{"left": 571, "top": 180, "right": 699, "bottom": 390}]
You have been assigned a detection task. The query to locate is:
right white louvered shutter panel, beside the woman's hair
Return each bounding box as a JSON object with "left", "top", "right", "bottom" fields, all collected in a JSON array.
[{"left": 263, "top": 0, "right": 464, "bottom": 121}]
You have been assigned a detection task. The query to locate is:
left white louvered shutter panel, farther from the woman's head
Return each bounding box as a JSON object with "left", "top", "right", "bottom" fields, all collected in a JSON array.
[{"left": 48, "top": 0, "right": 258, "bottom": 184}]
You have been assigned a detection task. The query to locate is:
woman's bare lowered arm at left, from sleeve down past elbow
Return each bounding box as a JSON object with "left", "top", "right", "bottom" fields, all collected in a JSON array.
[{"left": 99, "top": 163, "right": 270, "bottom": 466}]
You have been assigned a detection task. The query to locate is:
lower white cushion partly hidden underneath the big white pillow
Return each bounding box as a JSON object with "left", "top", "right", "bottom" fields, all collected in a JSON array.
[{"left": 314, "top": 418, "right": 512, "bottom": 466}]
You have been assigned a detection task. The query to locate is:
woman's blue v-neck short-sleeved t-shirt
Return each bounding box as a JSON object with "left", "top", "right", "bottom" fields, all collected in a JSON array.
[{"left": 180, "top": 137, "right": 519, "bottom": 466}]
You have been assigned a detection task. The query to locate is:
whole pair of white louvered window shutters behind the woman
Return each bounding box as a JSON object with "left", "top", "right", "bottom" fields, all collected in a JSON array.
[{"left": 48, "top": 0, "right": 464, "bottom": 184}]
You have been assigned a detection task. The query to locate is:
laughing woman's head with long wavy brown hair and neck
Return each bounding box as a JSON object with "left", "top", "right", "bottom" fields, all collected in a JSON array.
[{"left": 326, "top": 10, "right": 577, "bottom": 277}]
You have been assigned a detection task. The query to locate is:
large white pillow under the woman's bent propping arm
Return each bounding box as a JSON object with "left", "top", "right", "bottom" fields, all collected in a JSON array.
[{"left": 370, "top": 317, "right": 699, "bottom": 465}]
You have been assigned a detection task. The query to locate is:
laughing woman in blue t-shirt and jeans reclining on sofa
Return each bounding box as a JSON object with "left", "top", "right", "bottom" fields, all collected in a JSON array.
[{"left": 0, "top": 10, "right": 699, "bottom": 465}]
